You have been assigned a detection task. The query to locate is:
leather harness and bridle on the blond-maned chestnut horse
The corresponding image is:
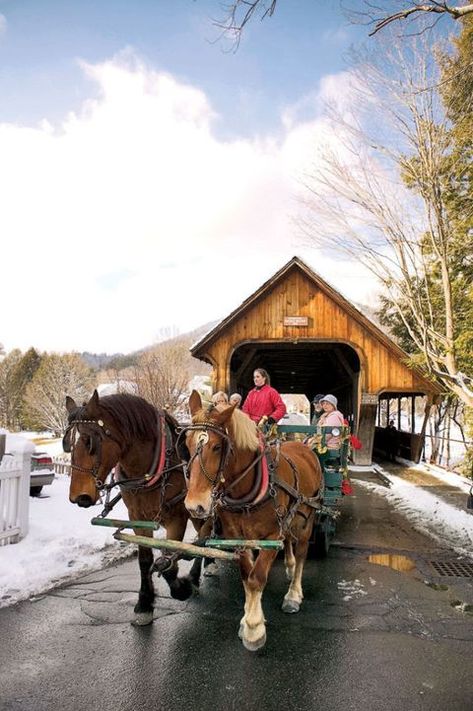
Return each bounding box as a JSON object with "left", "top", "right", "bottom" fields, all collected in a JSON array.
[{"left": 178, "top": 422, "right": 322, "bottom": 533}]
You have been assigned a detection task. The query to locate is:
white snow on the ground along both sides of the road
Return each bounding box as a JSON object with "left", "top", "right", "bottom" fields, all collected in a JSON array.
[{"left": 0, "top": 441, "right": 473, "bottom": 607}]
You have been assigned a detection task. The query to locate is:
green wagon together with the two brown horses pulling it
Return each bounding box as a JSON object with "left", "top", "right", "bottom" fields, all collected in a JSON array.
[{"left": 64, "top": 391, "right": 349, "bottom": 651}]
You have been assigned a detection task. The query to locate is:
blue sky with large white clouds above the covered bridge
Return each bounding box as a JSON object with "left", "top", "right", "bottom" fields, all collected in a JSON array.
[{"left": 0, "top": 0, "right": 374, "bottom": 353}]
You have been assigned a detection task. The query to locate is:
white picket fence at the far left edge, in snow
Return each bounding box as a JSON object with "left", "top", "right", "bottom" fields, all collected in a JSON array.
[{"left": 0, "top": 452, "right": 31, "bottom": 546}]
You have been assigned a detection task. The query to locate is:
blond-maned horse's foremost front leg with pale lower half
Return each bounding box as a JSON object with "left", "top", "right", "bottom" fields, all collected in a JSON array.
[{"left": 241, "top": 550, "right": 277, "bottom": 652}]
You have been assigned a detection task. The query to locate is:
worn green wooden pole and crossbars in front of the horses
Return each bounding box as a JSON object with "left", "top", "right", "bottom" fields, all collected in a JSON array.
[{"left": 91, "top": 518, "right": 284, "bottom": 560}]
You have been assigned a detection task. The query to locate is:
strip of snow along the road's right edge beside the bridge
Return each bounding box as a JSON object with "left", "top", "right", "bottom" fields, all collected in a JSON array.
[{"left": 357, "top": 462, "right": 473, "bottom": 559}]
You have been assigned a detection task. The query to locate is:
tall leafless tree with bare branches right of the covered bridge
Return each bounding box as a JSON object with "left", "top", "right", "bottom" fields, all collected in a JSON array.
[{"left": 300, "top": 33, "right": 473, "bottom": 405}]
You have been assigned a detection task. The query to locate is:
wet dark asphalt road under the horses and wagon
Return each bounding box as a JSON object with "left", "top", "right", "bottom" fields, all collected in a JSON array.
[{"left": 0, "top": 472, "right": 473, "bottom": 711}]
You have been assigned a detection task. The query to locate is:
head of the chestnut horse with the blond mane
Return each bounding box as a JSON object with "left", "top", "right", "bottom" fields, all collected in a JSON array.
[{"left": 184, "top": 390, "right": 254, "bottom": 518}]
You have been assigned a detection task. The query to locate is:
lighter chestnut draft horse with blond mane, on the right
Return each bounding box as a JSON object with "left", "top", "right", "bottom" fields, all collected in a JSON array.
[{"left": 185, "top": 390, "right": 322, "bottom": 651}]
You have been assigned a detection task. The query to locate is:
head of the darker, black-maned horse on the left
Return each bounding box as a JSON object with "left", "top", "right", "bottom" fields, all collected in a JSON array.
[{"left": 63, "top": 390, "right": 120, "bottom": 508}]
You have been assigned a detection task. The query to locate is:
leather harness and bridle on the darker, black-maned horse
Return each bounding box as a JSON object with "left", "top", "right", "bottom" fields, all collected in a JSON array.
[{"left": 63, "top": 411, "right": 186, "bottom": 517}]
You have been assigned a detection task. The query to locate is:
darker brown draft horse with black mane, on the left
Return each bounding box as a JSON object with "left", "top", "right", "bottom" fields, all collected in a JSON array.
[{"left": 63, "top": 391, "right": 202, "bottom": 625}]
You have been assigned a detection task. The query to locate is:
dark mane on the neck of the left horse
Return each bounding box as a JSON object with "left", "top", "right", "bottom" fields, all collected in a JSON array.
[{"left": 95, "top": 393, "right": 161, "bottom": 441}]
